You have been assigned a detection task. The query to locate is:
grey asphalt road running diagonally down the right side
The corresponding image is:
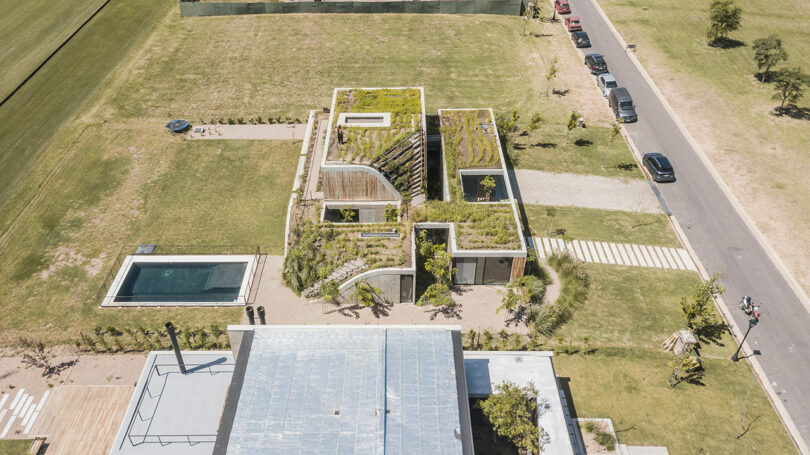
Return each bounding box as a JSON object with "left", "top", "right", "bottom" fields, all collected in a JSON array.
[{"left": 570, "top": 0, "right": 810, "bottom": 448}]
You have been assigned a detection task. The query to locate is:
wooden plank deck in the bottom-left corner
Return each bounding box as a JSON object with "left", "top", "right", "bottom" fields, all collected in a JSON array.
[{"left": 31, "top": 385, "right": 135, "bottom": 455}]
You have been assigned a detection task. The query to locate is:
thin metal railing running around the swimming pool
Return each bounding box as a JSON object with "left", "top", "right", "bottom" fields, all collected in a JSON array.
[{"left": 96, "top": 244, "right": 262, "bottom": 306}]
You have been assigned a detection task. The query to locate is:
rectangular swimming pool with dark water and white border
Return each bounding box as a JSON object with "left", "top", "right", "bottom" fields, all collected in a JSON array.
[{"left": 102, "top": 255, "right": 256, "bottom": 306}]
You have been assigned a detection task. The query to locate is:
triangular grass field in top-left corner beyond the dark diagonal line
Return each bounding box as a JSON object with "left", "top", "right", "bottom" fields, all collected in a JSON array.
[{"left": 0, "top": 0, "right": 104, "bottom": 99}]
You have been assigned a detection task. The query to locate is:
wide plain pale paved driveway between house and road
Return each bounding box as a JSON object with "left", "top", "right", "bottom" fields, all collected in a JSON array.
[{"left": 514, "top": 169, "right": 661, "bottom": 213}]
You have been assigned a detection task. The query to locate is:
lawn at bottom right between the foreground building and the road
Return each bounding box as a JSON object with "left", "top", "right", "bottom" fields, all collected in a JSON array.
[{"left": 554, "top": 348, "right": 796, "bottom": 455}]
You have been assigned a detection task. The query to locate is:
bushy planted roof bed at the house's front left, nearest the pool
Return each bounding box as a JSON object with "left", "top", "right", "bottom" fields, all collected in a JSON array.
[{"left": 283, "top": 220, "right": 411, "bottom": 293}]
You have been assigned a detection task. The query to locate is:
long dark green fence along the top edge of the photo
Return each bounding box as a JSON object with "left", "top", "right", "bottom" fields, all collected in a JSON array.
[{"left": 180, "top": 0, "right": 525, "bottom": 17}]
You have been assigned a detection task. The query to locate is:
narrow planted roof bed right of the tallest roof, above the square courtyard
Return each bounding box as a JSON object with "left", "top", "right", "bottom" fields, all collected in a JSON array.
[{"left": 440, "top": 109, "right": 501, "bottom": 175}]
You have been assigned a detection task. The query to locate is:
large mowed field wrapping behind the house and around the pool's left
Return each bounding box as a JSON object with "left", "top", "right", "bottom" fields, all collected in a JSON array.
[{"left": 0, "top": 10, "right": 610, "bottom": 344}]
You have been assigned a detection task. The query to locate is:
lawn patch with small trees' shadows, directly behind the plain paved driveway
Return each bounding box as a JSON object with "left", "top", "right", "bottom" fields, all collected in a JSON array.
[{"left": 509, "top": 124, "right": 644, "bottom": 179}]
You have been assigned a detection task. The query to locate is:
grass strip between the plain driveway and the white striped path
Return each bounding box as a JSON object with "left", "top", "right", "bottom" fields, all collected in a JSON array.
[{"left": 523, "top": 204, "right": 681, "bottom": 248}]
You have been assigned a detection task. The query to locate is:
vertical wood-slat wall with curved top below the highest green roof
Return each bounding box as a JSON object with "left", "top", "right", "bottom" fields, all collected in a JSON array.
[{"left": 321, "top": 166, "right": 402, "bottom": 201}]
